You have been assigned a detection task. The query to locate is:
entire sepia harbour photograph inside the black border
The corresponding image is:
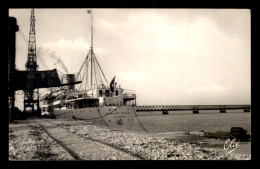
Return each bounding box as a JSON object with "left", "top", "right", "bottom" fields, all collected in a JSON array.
[{"left": 7, "top": 8, "right": 251, "bottom": 161}]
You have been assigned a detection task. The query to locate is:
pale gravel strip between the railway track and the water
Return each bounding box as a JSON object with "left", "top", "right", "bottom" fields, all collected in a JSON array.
[{"left": 54, "top": 119, "right": 251, "bottom": 160}]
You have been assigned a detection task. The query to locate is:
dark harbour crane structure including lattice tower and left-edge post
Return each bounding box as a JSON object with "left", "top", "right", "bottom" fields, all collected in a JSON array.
[{"left": 7, "top": 9, "right": 80, "bottom": 122}]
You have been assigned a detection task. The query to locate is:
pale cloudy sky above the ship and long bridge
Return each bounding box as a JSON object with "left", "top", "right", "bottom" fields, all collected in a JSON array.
[{"left": 9, "top": 8, "right": 251, "bottom": 109}]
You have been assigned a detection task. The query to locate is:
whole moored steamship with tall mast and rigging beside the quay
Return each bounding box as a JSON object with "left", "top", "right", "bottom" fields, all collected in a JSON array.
[{"left": 40, "top": 10, "right": 136, "bottom": 129}]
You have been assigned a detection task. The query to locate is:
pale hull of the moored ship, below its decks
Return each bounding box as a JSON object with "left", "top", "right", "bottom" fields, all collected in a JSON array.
[{"left": 53, "top": 106, "right": 136, "bottom": 129}]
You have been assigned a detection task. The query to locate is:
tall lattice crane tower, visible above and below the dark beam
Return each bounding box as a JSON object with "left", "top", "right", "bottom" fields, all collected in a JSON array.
[{"left": 24, "top": 9, "right": 40, "bottom": 115}]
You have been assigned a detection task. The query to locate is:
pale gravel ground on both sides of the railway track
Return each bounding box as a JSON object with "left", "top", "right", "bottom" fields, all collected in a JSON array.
[{"left": 9, "top": 119, "right": 251, "bottom": 160}]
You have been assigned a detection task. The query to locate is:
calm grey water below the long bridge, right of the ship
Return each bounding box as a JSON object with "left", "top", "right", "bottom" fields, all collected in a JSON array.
[{"left": 131, "top": 110, "right": 251, "bottom": 134}]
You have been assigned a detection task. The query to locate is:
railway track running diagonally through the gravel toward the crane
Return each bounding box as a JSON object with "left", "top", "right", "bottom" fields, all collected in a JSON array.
[{"left": 35, "top": 119, "right": 144, "bottom": 160}]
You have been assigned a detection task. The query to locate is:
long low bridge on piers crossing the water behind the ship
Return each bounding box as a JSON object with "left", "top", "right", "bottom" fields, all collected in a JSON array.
[{"left": 136, "top": 104, "right": 251, "bottom": 114}]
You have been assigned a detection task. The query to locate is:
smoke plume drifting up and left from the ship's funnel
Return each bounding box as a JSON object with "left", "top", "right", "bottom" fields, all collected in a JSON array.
[{"left": 37, "top": 47, "right": 69, "bottom": 74}]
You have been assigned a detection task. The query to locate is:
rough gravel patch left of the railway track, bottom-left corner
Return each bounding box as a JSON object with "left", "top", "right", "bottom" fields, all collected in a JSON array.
[{"left": 9, "top": 123, "right": 74, "bottom": 161}]
